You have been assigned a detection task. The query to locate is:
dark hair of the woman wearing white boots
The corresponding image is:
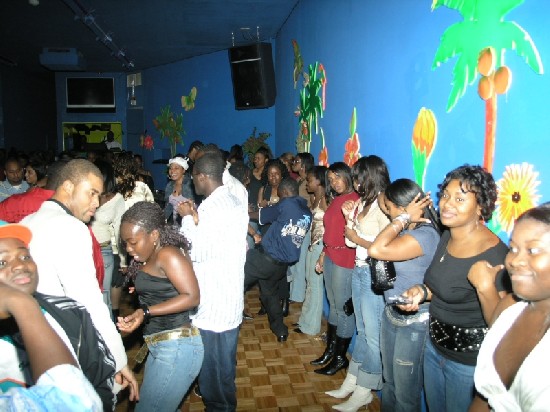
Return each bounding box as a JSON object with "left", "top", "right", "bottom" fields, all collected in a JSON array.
[{"left": 351, "top": 155, "right": 390, "bottom": 206}]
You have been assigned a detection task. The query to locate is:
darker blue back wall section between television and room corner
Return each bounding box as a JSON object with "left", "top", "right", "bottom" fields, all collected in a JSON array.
[{"left": 142, "top": 51, "right": 276, "bottom": 188}]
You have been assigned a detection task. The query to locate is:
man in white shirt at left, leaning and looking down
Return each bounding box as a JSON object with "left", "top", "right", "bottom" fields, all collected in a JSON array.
[{"left": 21, "top": 159, "right": 137, "bottom": 398}]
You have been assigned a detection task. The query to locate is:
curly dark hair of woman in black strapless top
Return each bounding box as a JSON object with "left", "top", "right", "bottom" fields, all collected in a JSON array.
[{"left": 120, "top": 201, "right": 191, "bottom": 280}]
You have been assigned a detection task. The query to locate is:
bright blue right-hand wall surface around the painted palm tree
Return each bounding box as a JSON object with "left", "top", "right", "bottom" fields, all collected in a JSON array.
[{"left": 276, "top": 0, "right": 550, "bottom": 237}]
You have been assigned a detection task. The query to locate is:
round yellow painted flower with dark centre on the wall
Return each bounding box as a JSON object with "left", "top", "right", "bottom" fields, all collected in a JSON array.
[{"left": 496, "top": 162, "right": 540, "bottom": 233}]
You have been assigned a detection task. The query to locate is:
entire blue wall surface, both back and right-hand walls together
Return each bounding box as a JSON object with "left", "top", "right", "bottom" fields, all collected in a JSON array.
[{"left": 52, "top": 0, "right": 550, "bottom": 238}]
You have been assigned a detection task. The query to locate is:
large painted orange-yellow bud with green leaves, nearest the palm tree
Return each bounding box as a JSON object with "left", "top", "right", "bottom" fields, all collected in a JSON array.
[{"left": 411, "top": 107, "right": 437, "bottom": 189}]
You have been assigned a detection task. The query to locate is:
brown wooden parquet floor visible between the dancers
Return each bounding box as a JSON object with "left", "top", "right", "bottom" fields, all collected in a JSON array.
[{"left": 116, "top": 289, "right": 380, "bottom": 412}]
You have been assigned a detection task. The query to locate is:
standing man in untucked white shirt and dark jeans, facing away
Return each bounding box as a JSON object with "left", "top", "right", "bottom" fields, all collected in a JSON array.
[{"left": 178, "top": 152, "right": 248, "bottom": 411}]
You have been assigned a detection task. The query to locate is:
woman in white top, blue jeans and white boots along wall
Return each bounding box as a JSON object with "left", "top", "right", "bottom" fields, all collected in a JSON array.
[{"left": 326, "top": 155, "right": 390, "bottom": 411}]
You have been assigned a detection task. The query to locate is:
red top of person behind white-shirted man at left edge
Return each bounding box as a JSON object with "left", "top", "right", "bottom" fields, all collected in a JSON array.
[{"left": 0, "top": 187, "right": 55, "bottom": 223}]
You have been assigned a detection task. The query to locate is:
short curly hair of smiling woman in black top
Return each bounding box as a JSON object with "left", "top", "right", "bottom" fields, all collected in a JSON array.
[{"left": 437, "top": 164, "right": 497, "bottom": 222}]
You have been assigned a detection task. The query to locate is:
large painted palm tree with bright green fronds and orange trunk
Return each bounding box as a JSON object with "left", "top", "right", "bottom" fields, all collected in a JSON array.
[{"left": 432, "top": 0, "right": 543, "bottom": 171}]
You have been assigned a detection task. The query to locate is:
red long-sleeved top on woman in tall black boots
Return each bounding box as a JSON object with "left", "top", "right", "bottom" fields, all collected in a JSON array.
[{"left": 323, "top": 192, "right": 359, "bottom": 269}]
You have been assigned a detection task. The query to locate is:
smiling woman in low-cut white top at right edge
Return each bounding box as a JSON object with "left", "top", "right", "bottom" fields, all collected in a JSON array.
[{"left": 470, "top": 203, "right": 550, "bottom": 412}]
